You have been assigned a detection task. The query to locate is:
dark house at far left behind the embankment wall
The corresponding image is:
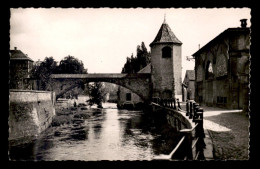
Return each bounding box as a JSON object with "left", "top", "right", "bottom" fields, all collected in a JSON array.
[{"left": 9, "top": 47, "right": 33, "bottom": 89}]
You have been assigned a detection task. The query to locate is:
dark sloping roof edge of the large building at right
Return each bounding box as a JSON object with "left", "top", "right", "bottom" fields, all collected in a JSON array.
[{"left": 192, "top": 27, "right": 250, "bottom": 57}]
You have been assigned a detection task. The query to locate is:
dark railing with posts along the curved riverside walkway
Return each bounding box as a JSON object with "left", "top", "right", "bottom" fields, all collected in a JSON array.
[{"left": 153, "top": 98, "right": 206, "bottom": 160}]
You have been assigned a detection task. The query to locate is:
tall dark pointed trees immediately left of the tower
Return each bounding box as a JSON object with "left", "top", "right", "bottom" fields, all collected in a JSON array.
[{"left": 122, "top": 42, "right": 151, "bottom": 73}]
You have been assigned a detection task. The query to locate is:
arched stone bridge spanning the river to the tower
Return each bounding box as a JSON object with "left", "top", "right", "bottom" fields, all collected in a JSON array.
[{"left": 51, "top": 73, "right": 152, "bottom": 102}]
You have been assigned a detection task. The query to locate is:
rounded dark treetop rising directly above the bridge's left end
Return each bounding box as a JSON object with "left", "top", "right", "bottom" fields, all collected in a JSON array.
[{"left": 58, "top": 55, "right": 84, "bottom": 74}]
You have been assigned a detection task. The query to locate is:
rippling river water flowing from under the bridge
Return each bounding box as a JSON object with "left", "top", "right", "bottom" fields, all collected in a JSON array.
[{"left": 9, "top": 103, "right": 182, "bottom": 161}]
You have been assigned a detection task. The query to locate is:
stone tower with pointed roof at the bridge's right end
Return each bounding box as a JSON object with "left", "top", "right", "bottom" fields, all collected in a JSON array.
[{"left": 150, "top": 20, "right": 182, "bottom": 100}]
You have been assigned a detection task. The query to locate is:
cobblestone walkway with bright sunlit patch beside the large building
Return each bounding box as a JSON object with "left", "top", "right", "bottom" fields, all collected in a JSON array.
[{"left": 182, "top": 103, "right": 250, "bottom": 160}]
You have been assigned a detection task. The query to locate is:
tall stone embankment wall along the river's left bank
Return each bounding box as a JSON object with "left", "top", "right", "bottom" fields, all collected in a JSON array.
[{"left": 8, "top": 90, "right": 55, "bottom": 144}]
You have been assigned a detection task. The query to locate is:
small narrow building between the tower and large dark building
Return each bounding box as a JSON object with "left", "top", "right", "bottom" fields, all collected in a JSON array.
[{"left": 182, "top": 70, "right": 195, "bottom": 101}]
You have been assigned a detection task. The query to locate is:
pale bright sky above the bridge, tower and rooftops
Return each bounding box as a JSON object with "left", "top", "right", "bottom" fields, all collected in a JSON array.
[{"left": 10, "top": 8, "right": 251, "bottom": 78}]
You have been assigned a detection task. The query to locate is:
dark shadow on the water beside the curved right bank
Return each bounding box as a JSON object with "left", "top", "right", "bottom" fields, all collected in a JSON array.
[{"left": 119, "top": 108, "right": 183, "bottom": 159}]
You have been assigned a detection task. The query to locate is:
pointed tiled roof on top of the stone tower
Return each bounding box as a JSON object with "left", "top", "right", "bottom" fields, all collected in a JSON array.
[{"left": 150, "top": 22, "right": 182, "bottom": 46}]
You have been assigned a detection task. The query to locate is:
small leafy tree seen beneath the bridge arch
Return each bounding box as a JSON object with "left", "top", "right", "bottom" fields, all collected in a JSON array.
[{"left": 87, "top": 82, "right": 106, "bottom": 108}]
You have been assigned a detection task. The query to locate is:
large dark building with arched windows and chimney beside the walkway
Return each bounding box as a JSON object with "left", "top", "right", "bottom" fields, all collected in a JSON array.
[{"left": 193, "top": 19, "right": 250, "bottom": 111}]
